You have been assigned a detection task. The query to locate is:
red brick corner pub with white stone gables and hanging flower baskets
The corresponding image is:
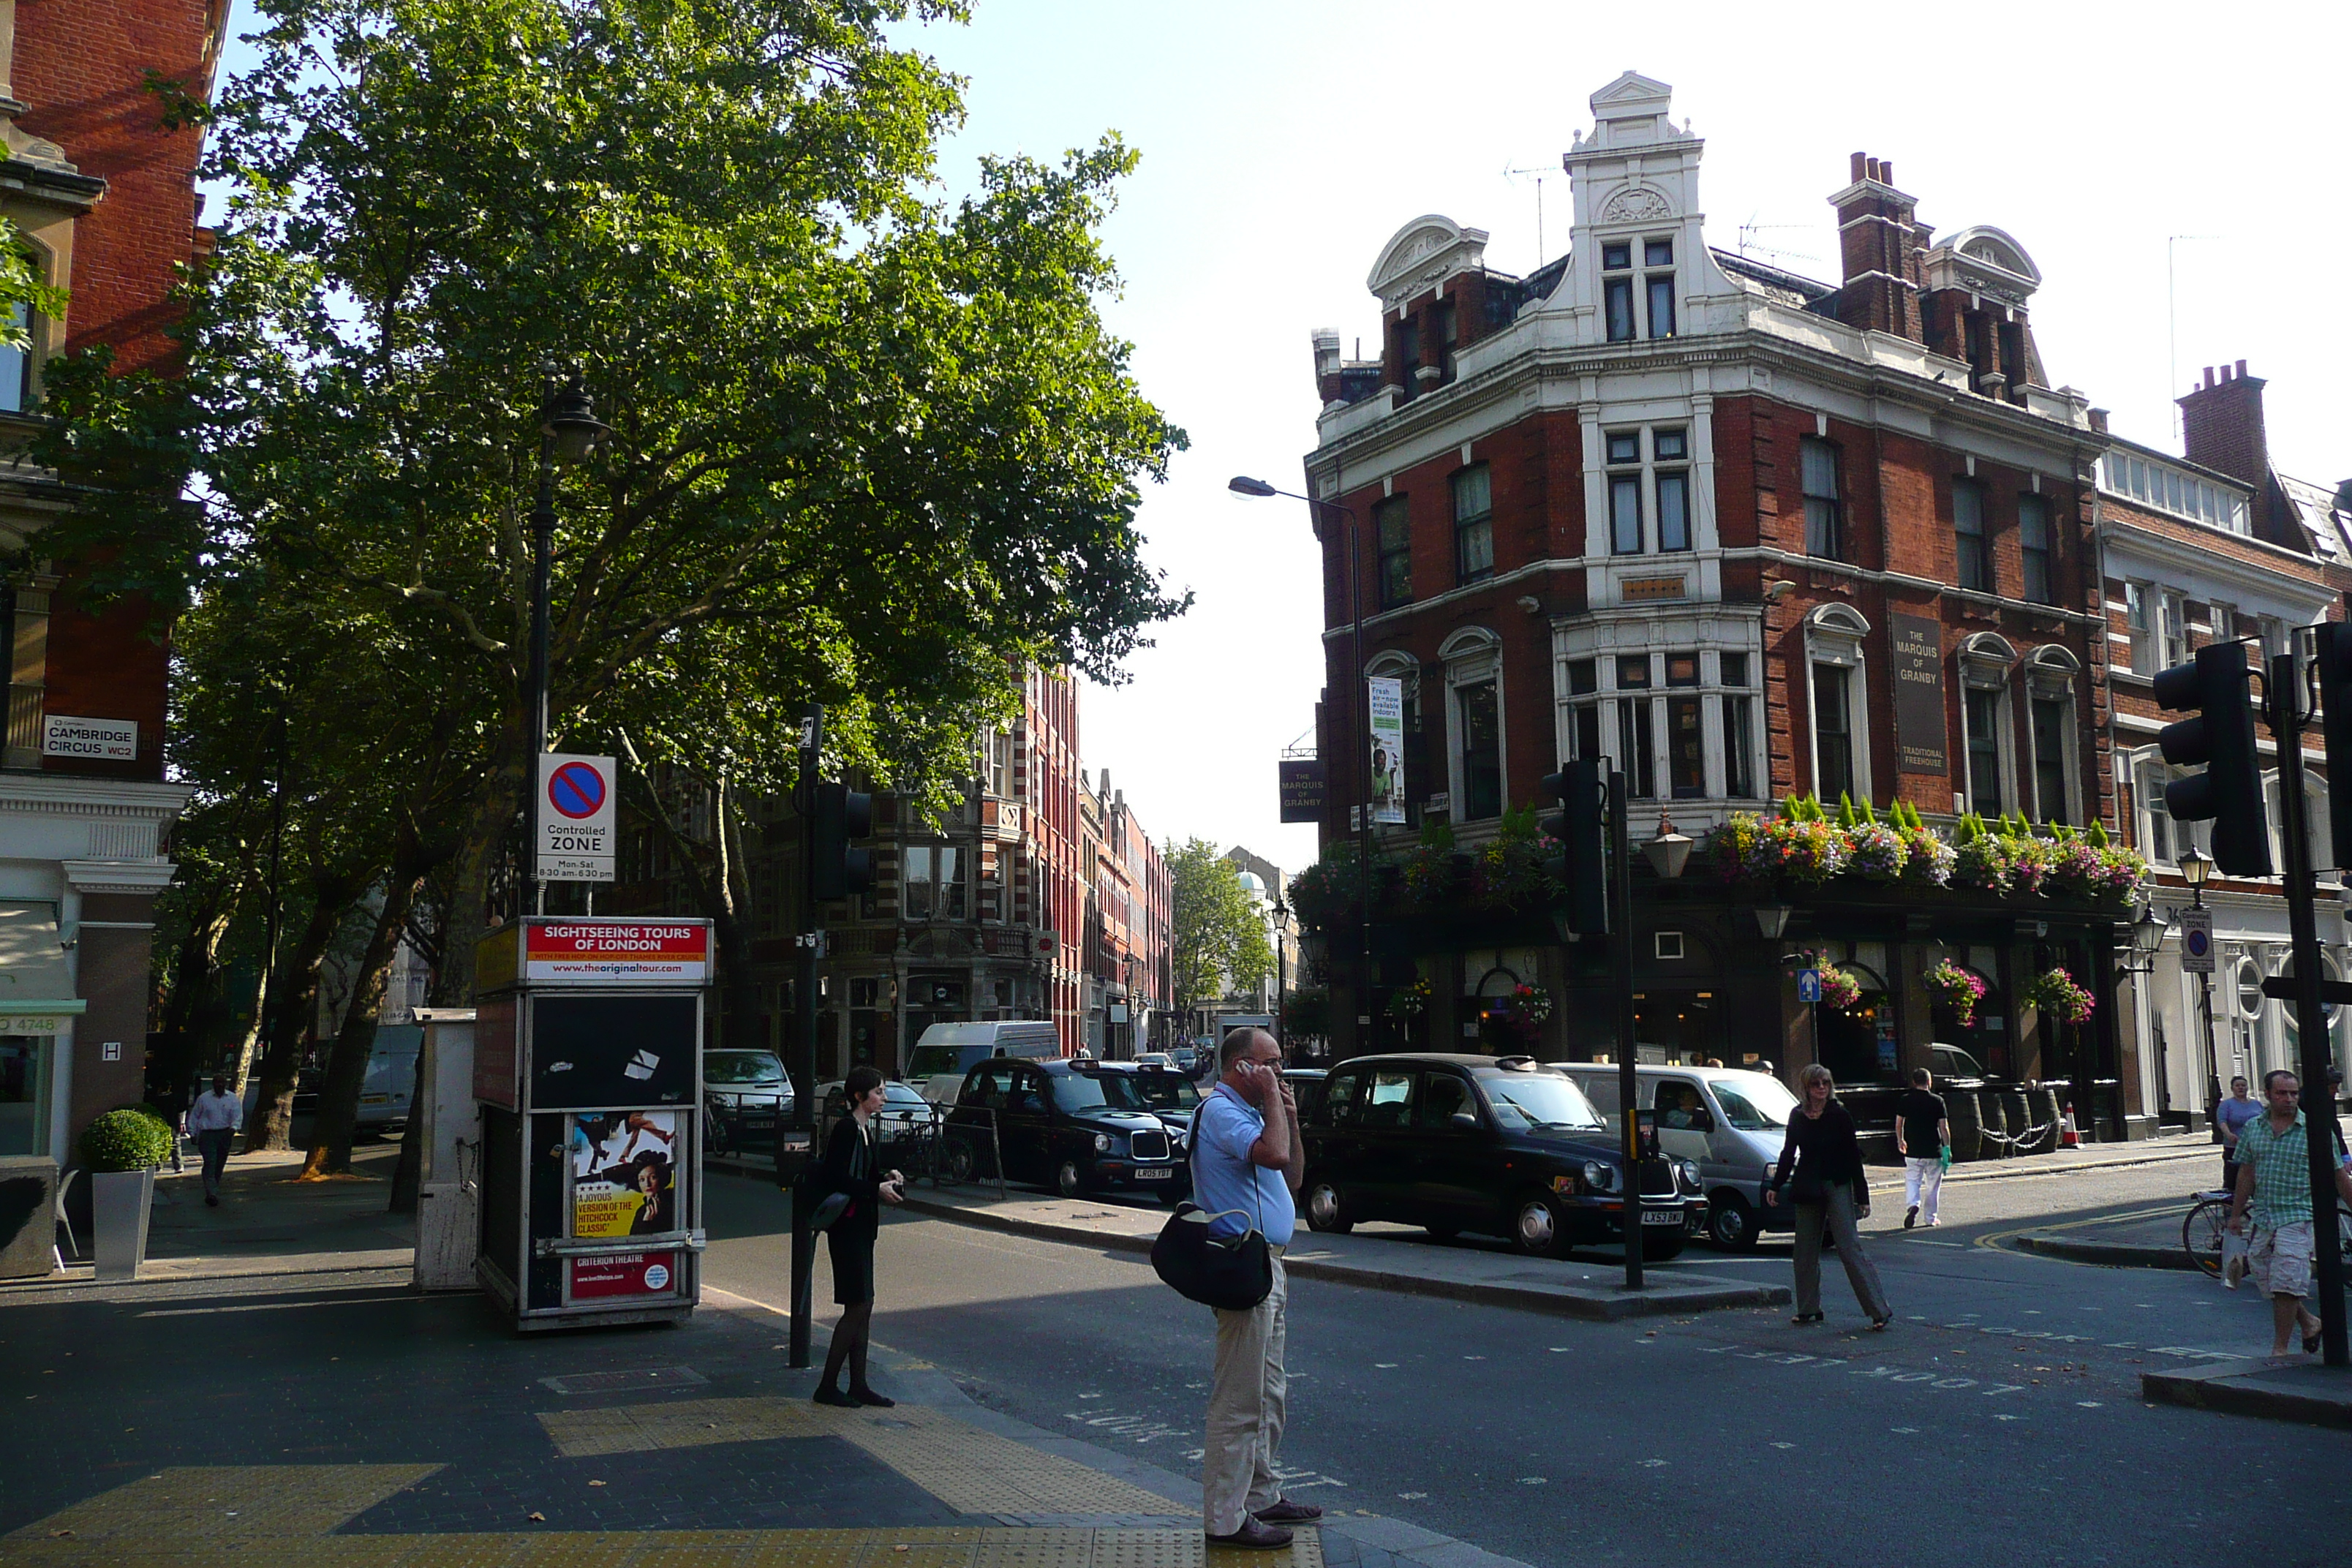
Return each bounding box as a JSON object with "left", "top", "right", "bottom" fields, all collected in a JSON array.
[{"left": 1305, "top": 73, "right": 2147, "bottom": 1131}]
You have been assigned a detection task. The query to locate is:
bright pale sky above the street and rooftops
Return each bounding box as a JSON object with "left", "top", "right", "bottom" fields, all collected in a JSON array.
[{"left": 211, "top": 0, "right": 2352, "bottom": 870}]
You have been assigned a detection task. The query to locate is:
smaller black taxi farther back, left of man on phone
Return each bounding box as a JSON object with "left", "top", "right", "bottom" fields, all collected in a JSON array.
[{"left": 946, "top": 1058, "right": 1193, "bottom": 1204}]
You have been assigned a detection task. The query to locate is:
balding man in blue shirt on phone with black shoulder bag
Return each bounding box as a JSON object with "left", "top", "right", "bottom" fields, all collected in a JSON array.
[{"left": 1193, "top": 1028, "right": 1322, "bottom": 1551}]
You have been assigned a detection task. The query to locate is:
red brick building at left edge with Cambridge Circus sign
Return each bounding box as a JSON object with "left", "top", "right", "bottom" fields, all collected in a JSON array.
[{"left": 0, "top": 0, "right": 214, "bottom": 1161}]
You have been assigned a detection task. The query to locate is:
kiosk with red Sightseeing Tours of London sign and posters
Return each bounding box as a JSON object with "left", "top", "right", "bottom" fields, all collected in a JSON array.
[{"left": 472, "top": 917, "right": 710, "bottom": 1330}]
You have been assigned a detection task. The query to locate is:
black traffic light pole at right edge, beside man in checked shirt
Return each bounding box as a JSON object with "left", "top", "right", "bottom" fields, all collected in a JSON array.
[{"left": 2263, "top": 651, "right": 2352, "bottom": 1366}]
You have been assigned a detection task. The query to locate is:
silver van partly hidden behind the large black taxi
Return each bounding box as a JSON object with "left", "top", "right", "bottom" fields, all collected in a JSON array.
[{"left": 1553, "top": 1063, "right": 1797, "bottom": 1251}]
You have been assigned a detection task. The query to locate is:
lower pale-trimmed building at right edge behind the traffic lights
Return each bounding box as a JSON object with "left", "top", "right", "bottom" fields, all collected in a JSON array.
[{"left": 2098, "top": 360, "right": 2352, "bottom": 1126}]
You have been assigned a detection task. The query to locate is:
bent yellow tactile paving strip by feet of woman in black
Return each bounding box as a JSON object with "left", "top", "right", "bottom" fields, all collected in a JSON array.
[{"left": 538, "top": 1399, "right": 1190, "bottom": 1523}]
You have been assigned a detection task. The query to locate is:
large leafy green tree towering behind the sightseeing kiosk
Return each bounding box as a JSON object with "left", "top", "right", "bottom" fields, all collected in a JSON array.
[{"left": 42, "top": 0, "right": 1186, "bottom": 997}]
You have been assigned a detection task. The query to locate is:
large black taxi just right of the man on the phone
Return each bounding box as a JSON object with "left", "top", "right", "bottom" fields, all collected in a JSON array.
[{"left": 1300, "top": 1053, "right": 1708, "bottom": 1258}]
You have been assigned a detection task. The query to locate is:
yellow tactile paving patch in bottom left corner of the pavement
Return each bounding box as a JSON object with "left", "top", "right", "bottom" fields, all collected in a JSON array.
[{"left": 0, "top": 1465, "right": 440, "bottom": 1561}]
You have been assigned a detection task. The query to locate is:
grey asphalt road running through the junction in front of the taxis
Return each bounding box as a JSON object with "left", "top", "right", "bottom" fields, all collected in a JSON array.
[{"left": 706, "top": 1161, "right": 2352, "bottom": 1568}]
